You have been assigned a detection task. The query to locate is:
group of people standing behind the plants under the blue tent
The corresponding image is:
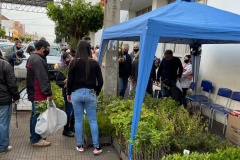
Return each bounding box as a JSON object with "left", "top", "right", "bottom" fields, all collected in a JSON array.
[{"left": 119, "top": 43, "right": 193, "bottom": 105}]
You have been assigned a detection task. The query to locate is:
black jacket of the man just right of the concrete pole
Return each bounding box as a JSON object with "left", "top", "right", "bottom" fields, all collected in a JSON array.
[{"left": 119, "top": 54, "right": 132, "bottom": 78}]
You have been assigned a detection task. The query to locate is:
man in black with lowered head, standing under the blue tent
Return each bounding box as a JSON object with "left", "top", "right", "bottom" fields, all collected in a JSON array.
[{"left": 156, "top": 50, "right": 183, "bottom": 97}]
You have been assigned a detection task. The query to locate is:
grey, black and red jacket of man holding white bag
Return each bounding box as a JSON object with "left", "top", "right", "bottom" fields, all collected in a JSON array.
[{"left": 26, "top": 53, "right": 52, "bottom": 102}]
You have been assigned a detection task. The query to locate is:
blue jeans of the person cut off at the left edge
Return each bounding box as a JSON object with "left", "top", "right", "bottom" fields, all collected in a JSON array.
[{"left": 0, "top": 104, "right": 12, "bottom": 152}]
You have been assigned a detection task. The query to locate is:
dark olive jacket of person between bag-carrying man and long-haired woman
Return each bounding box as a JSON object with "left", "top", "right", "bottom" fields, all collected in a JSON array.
[{"left": 56, "top": 64, "right": 68, "bottom": 97}]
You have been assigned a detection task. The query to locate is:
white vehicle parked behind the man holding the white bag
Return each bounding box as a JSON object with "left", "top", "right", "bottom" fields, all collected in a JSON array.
[{"left": 14, "top": 42, "right": 61, "bottom": 80}]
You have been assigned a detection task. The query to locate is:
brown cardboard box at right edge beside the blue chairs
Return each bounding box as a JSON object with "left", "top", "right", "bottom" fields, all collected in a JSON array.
[{"left": 226, "top": 114, "right": 240, "bottom": 145}]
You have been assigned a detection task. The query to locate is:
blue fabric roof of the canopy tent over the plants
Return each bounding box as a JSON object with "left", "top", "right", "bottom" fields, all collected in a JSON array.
[{"left": 103, "top": 0, "right": 240, "bottom": 44}]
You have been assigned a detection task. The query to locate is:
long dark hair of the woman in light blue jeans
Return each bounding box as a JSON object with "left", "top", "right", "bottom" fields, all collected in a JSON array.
[{"left": 69, "top": 40, "right": 91, "bottom": 80}]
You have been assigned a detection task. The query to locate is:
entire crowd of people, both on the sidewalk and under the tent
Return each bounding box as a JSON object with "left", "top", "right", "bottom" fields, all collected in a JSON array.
[{"left": 0, "top": 37, "right": 192, "bottom": 154}]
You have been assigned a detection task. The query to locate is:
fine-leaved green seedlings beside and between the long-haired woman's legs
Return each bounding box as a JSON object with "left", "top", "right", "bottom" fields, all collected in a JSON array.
[{"left": 84, "top": 112, "right": 114, "bottom": 137}]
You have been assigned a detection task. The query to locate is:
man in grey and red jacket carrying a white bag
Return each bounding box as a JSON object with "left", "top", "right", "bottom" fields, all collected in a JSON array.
[{"left": 26, "top": 40, "right": 53, "bottom": 147}]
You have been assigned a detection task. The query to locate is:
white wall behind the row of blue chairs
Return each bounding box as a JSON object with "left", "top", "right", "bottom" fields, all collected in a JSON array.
[{"left": 198, "top": 0, "right": 240, "bottom": 123}]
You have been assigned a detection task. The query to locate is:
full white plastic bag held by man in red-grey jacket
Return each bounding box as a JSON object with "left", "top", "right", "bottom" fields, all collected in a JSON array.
[{"left": 35, "top": 101, "right": 67, "bottom": 137}]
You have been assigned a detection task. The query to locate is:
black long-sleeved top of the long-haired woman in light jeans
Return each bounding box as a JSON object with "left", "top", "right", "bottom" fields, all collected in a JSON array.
[{"left": 67, "top": 59, "right": 103, "bottom": 95}]
